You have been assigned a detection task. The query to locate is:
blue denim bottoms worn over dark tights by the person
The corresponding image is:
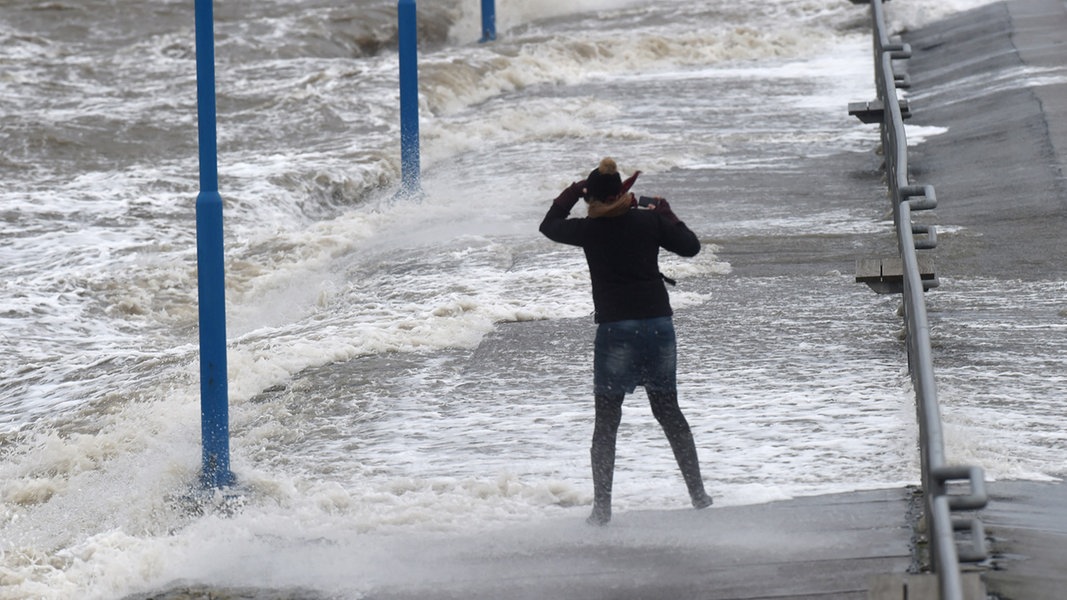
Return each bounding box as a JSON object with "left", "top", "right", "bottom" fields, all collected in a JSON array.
[{"left": 593, "top": 317, "right": 678, "bottom": 396}]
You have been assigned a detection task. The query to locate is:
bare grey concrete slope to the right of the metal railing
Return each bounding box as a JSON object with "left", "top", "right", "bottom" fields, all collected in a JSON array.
[{"left": 904, "top": 0, "right": 1067, "bottom": 600}]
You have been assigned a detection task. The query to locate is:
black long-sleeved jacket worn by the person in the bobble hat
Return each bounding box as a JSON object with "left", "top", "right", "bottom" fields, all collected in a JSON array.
[{"left": 541, "top": 186, "right": 700, "bottom": 323}]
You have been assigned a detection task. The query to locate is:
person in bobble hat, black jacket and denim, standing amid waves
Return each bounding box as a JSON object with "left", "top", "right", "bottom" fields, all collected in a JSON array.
[{"left": 540, "top": 158, "right": 712, "bottom": 525}]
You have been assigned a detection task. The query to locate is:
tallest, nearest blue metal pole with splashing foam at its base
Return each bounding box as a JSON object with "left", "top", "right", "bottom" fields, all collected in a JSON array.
[{"left": 195, "top": 0, "right": 234, "bottom": 488}]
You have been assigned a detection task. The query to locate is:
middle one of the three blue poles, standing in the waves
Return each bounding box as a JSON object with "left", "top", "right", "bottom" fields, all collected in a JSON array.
[{"left": 397, "top": 0, "right": 421, "bottom": 193}]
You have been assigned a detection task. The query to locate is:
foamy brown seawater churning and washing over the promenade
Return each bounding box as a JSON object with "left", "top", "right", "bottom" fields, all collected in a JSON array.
[{"left": 0, "top": 0, "right": 1067, "bottom": 599}]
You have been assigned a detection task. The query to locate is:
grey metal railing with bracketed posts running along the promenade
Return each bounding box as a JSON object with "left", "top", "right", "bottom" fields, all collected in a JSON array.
[{"left": 849, "top": 0, "right": 988, "bottom": 600}]
